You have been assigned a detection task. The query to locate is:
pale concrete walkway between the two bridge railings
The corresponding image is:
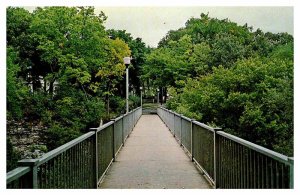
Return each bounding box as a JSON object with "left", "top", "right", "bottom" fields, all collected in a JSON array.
[{"left": 100, "top": 115, "right": 211, "bottom": 189}]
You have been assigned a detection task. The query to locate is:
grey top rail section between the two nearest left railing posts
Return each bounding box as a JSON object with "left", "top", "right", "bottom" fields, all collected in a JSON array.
[{"left": 37, "top": 131, "right": 95, "bottom": 165}]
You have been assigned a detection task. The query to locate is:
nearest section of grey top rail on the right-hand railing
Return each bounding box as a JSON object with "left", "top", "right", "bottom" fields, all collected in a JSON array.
[{"left": 216, "top": 131, "right": 290, "bottom": 164}]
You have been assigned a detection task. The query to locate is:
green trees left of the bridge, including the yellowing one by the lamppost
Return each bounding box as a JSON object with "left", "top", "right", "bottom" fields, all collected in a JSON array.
[{"left": 7, "top": 7, "right": 146, "bottom": 171}]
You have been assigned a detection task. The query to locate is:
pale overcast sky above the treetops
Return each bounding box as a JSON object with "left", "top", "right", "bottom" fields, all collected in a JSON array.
[{"left": 95, "top": 6, "right": 294, "bottom": 47}]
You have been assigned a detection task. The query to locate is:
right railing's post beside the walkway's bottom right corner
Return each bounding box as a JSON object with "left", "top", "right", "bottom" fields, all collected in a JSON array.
[{"left": 214, "top": 128, "right": 222, "bottom": 189}]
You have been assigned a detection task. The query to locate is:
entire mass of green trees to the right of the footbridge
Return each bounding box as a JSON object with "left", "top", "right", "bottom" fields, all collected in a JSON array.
[{"left": 142, "top": 14, "right": 293, "bottom": 156}]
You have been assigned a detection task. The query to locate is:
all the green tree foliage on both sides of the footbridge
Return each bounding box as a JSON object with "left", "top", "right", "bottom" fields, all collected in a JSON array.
[{"left": 7, "top": 7, "right": 294, "bottom": 172}]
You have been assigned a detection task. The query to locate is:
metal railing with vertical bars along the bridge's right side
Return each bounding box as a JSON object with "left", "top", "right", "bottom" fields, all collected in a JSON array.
[{"left": 157, "top": 107, "right": 294, "bottom": 189}]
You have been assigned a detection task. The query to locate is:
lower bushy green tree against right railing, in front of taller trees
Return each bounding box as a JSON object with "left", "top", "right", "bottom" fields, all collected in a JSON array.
[{"left": 168, "top": 58, "right": 293, "bottom": 155}]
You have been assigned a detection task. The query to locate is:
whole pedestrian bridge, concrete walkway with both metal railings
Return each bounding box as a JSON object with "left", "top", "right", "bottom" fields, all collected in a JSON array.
[{"left": 6, "top": 108, "right": 294, "bottom": 189}]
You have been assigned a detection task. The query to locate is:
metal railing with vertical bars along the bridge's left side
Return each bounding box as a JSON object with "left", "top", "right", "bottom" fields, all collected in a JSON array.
[{"left": 6, "top": 107, "right": 142, "bottom": 189}]
